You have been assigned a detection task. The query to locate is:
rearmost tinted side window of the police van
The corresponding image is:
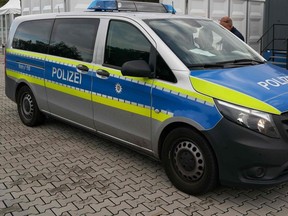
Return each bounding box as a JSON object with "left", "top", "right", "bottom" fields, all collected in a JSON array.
[{"left": 12, "top": 20, "right": 53, "bottom": 53}]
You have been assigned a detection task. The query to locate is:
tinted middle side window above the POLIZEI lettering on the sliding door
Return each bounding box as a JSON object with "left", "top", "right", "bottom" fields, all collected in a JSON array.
[{"left": 49, "top": 18, "right": 99, "bottom": 62}]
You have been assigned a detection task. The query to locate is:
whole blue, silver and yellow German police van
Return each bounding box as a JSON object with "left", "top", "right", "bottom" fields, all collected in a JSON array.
[{"left": 5, "top": 1, "right": 288, "bottom": 195}]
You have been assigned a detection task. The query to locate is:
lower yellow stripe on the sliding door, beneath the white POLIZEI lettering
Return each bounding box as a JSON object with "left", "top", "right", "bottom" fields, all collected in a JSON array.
[{"left": 46, "top": 81, "right": 91, "bottom": 100}]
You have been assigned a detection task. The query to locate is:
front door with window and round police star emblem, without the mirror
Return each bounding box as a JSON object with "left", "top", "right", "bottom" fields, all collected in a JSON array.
[{"left": 92, "top": 20, "right": 153, "bottom": 149}]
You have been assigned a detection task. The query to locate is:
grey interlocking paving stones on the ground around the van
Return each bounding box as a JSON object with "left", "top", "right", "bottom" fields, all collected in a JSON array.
[{"left": 0, "top": 57, "right": 288, "bottom": 216}]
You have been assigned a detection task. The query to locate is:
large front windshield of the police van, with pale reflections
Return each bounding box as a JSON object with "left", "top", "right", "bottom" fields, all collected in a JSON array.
[{"left": 145, "top": 18, "right": 264, "bottom": 69}]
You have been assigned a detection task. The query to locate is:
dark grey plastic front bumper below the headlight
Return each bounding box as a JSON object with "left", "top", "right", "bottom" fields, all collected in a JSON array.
[{"left": 204, "top": 118, "right": 288, "bottom": 186}]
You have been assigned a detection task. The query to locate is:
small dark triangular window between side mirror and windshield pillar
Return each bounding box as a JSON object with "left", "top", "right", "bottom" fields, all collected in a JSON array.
[{"left": 156, "top": 54, "right": 177, "bottom": 82}]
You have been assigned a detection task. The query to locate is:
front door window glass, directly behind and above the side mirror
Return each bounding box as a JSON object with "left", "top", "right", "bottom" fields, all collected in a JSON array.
[{"left": 104, "top": 20, "right": 151, "bottom": 67}]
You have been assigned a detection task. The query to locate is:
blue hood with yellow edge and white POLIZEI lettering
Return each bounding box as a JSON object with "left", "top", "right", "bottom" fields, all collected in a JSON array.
[{"left": 190, "top": 64, "right": 288, "bottom": 114}]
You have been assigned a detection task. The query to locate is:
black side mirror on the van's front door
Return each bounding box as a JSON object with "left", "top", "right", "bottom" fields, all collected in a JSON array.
[{"left": 121, "top": 60, "right": 152, "bottom": 77}]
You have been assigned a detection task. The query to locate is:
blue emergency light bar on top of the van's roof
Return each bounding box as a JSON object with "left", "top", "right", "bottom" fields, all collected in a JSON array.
[{"left": 87, "top": 0, "right": 176, "bottom": 13}]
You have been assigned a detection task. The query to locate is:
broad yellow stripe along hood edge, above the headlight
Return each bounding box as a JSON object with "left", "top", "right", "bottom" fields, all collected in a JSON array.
[{"left": 190, "top": 77, "right": 281, "bottom": 114}]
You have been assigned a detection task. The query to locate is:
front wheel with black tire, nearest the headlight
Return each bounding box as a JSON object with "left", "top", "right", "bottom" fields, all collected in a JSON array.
[{"left": 162, "top": 127, "right": 218, "bottom": 195}]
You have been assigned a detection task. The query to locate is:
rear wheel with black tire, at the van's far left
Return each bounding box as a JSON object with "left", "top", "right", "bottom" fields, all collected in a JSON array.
[{"left": 17, "top": 86, "right": 45, "bottom": 127}]
